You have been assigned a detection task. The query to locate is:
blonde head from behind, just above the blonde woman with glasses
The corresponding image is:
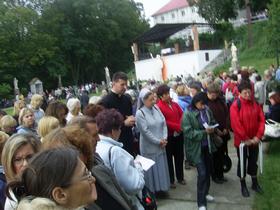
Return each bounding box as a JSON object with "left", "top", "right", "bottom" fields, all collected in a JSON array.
[{"left": 38, "top": 116, "right": 59, "bottom": 141}]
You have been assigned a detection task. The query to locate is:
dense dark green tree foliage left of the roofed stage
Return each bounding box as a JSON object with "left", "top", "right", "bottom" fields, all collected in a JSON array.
[{"left": 0, "top": 0, "right": 148, "bottom": 97}]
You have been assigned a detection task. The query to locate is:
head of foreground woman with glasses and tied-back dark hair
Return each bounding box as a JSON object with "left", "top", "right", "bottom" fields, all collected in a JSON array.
[{"left": 8, "top": 147, "right": 97, "bottom": 209}]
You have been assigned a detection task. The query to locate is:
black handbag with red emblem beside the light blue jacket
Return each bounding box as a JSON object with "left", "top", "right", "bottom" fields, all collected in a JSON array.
[{"left": 137, "top": 186, "right": 157, "bottom": 210}]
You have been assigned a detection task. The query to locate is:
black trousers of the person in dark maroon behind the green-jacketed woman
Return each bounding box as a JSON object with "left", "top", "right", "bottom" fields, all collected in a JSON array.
[{"left": 212, "top": 138, "right": 228, "bottom": 179}]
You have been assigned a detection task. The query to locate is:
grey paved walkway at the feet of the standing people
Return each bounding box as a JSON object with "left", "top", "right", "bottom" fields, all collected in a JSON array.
[{"left": 158, "top": 140, "right": 255, "bottom": 210}]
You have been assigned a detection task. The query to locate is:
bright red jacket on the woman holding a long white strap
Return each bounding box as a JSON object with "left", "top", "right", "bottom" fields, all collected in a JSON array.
[{"left": 230, "top": 97, "right": 265, "bottom": 147}]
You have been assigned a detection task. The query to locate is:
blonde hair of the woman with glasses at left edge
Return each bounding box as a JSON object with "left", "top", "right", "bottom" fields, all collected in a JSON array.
[{"left": 1, "top": 134, "right": 40, "bottom": 182}]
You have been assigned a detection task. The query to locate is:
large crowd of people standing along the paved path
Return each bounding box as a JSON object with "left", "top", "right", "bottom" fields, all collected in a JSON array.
[{"left": 0, "top": 68, "right": 280, "bottom": 210}]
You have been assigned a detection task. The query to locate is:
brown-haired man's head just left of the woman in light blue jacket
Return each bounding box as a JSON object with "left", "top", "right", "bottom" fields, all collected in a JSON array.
[{"left": 68, "top": 115, "right": 100, "bottom": 153}]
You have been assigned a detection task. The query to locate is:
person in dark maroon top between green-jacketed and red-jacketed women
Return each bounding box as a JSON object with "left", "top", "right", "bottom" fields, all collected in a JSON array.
[{"left": 207, "top": 83, "right": 230, "bottom": 184}]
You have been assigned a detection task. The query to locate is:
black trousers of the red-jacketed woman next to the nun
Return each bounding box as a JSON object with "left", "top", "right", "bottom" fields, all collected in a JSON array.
[{"left": 166, "top": 134, "right": 184, "bottom": 183}]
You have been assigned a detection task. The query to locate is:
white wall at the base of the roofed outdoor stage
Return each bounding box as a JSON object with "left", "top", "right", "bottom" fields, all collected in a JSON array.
[{"left": 134, "top": 50, "right": 222, "bottom": 81}]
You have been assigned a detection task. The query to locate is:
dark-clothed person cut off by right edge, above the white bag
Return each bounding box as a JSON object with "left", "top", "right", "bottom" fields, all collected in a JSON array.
[{"left": 266, "top": 92, "right": 280, "bottom": 123}]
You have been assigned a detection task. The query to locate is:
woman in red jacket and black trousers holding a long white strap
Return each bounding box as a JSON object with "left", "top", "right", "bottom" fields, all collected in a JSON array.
[{"left": 230, "top": 80, "right": 265, "bottom": 197}]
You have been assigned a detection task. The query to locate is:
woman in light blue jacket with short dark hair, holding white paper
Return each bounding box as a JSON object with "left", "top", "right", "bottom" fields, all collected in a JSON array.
[{"left": 96, "top": 109, "right": 145, "bottom": 209}]
